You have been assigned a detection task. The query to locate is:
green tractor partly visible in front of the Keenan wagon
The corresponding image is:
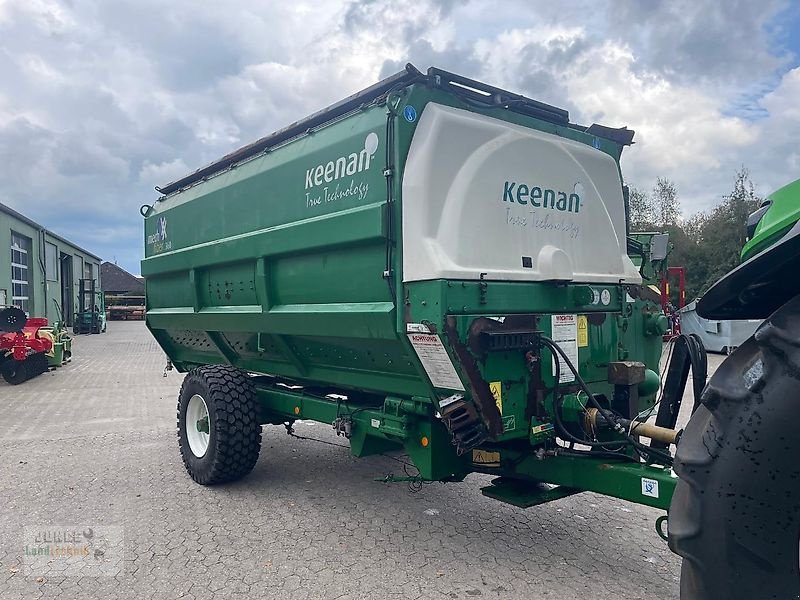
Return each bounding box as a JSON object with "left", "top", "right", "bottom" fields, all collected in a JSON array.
[{"left": 669, "top": 180, "right": 800, "bottom": 599}]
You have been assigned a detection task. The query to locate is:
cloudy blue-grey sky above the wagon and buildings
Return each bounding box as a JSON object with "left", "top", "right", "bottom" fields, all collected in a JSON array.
[{"left": 0, "top": 0, "right": 800, "bottom": 273}]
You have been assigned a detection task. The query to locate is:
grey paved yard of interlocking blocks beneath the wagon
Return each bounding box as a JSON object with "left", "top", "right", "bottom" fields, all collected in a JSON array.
[{"left": 0, "top": 322, "right": 719, "bottom": 600}]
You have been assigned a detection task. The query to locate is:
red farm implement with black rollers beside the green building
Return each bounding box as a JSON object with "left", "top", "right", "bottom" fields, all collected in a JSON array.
[{"left": 0, "top": 306, "right": 72, "bottom": 385}]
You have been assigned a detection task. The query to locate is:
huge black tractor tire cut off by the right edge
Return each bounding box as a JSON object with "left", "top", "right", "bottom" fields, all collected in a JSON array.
[{"left": 669, "top": 296, "right": 800, "bottom": 600}]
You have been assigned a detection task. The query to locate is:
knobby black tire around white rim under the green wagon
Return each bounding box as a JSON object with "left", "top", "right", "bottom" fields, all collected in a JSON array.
[{"left": 178, "top": 365, "right": 261, "bottom": 485}]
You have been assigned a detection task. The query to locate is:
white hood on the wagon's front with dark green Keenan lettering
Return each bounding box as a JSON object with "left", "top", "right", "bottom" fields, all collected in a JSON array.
[{"left": 402, "top": 104, "right": 641, "bottom": 283}]
